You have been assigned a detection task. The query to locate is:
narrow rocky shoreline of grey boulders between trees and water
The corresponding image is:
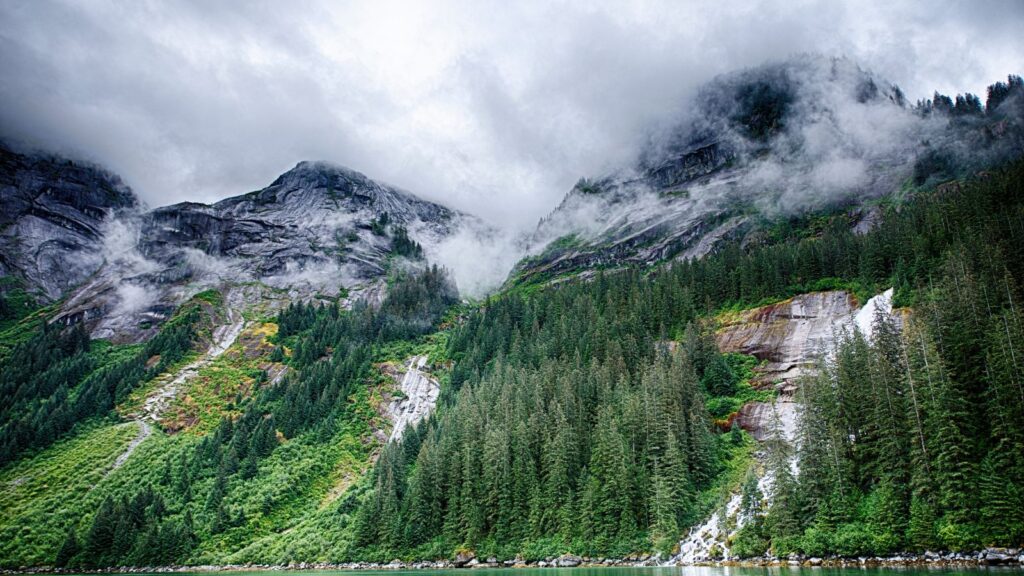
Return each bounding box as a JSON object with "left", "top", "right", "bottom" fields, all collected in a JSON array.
[{"left": 0, "top": 548, "right": 1024, "bottom": 574}]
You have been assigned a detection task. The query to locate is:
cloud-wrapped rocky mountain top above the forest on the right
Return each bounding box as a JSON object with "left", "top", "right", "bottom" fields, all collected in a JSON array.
[{"left": 512, "top": 55, "right": 1024, "bottom": 283}]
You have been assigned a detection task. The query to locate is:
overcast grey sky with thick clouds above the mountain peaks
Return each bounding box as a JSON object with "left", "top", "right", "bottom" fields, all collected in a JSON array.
[{"left": 0, "top": 0, "right": 1024, "bottom": 227}]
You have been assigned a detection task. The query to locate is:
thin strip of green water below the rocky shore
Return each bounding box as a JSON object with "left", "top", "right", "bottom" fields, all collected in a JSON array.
[{"left": 61, "top": 566, "right": 1024, "bottom": 576}]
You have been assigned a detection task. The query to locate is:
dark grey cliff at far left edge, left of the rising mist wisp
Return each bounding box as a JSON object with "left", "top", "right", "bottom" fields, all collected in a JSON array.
[{"left": 0, "top": 146, "right": 137, "bottom": 301}]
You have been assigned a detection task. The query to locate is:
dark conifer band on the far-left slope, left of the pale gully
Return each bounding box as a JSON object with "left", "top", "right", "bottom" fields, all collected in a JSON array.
[{"left": 0, "top": 302, "right": 202, "bottom": 466}]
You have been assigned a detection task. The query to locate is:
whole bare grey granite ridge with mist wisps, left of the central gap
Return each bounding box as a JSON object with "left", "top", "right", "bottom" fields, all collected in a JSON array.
[{"left": 0, "top": 145, "right": 489, "bottom": 341}]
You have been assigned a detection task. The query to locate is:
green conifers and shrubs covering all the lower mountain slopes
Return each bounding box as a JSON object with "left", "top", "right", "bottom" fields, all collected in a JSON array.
[{"left": 0, "top": 156, "right": 1024, "bottom": 568}]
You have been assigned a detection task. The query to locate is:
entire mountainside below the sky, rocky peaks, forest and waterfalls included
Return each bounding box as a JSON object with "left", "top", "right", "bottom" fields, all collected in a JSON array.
[{"left": 0, "top": 56, "right": 1024, "bottom": 570}]
